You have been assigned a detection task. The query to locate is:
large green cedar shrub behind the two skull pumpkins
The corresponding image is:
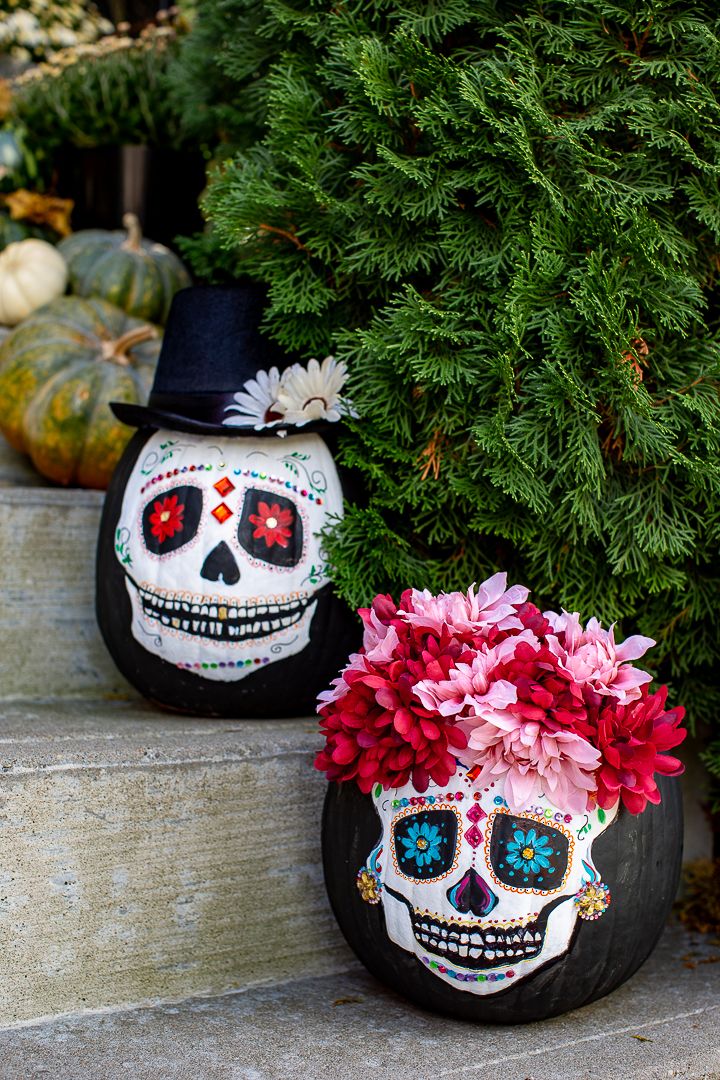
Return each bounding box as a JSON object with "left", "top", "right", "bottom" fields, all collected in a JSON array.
[{"left": 198, "top": 0, "right": 720, "bottom": 774}]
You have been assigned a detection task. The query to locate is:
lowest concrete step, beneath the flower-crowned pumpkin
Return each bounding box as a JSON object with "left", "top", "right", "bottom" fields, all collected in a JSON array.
[{"left": 0, "top": 927, "right": 720, "bottom": 1080}]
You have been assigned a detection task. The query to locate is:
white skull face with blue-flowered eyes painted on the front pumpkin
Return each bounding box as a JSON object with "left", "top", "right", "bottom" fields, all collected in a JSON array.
[{"left": 357, "top": 767, "right": 617, "bottom": 995}]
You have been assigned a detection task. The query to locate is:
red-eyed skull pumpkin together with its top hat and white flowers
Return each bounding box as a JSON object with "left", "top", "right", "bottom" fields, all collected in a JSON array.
[{"left": 97, "top": 287, "right": 356, "bottom": 717}]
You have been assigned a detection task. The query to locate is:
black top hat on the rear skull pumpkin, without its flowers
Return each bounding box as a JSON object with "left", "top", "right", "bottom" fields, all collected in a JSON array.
[{"left": 110, "top": 285, "right": 338, "bottom": 436}]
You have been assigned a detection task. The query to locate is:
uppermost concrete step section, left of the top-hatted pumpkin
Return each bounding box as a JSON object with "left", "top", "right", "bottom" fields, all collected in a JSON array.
[{"left": 0, "top": 485, "right": 135, "bottom": 700}]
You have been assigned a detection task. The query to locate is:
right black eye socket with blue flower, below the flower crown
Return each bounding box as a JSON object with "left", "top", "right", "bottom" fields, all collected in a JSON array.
[{"left": 490, "top": 813, "right": 569, "bottom": 892}]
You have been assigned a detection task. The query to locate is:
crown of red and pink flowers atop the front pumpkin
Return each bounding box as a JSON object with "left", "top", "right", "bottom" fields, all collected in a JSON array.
[{"left": 315, "top": 573, "right": 687, "bottom": 813}]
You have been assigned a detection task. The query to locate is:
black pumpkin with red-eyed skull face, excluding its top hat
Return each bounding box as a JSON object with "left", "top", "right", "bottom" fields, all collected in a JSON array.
[{"left": 97, "top": 428, "right": 358, "bottom": 717}]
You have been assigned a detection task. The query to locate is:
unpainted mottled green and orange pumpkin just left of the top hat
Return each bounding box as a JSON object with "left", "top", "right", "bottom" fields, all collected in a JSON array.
[{"left": 0, "top": 291, "right": 160, "bottom": 488}]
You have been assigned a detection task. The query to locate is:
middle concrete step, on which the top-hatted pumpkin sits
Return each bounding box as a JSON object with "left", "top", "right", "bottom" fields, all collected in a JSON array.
[{"left": 0, "top": 701, "right": 350, "bottom": 1026}]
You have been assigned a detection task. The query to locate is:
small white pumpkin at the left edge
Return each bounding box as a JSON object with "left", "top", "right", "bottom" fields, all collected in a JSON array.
[{"left": 0, "top": 240, "right": 68, "bottom": 326}]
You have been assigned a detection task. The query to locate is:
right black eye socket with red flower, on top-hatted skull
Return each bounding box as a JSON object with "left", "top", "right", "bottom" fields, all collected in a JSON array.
[{"left": 237, "top": 487, "right": 302, "bottom": 566}]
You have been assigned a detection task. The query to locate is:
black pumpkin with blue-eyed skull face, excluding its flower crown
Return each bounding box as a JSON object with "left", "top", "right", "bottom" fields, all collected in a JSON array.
[{"left": 323, "top": 767, "right": 682, "bottom": 1024}]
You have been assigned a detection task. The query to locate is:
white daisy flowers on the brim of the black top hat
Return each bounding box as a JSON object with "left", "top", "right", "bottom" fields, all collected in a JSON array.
[{"left": 222, "top": 356, "right": 352, "bottom": 431}]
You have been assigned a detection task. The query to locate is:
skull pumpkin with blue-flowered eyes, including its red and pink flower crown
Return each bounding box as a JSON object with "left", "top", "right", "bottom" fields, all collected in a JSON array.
[{"left": 316, "top": 575, "right": 685, "bottom": 1023}]
